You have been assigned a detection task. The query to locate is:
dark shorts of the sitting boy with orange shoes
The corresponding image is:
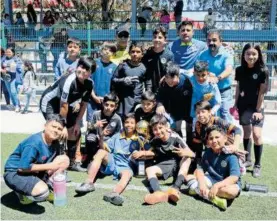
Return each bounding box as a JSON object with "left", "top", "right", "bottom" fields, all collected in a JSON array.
[{"left": 153, "top": 159, "right": 179, "bottom": 180}]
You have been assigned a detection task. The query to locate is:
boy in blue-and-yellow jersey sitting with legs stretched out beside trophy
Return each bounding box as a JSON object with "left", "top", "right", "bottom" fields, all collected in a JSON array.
[{"left": 75, "top": 113, "right": 147, "bottom": 206}]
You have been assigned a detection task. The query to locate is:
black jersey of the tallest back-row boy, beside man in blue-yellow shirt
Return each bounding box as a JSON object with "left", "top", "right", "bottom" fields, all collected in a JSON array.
[{"left": 142, "top": 48, "right": 174, "bottom": 93}]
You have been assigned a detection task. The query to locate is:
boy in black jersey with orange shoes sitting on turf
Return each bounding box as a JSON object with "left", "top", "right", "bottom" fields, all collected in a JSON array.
[{"left": 133, "top": 115, "right": 194, "bottom": 205}]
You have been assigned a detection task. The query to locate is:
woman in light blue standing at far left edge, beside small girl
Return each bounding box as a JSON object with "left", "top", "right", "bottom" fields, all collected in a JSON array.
[{"left": 1, "top": 48, "right": 23, "bottom": 112}]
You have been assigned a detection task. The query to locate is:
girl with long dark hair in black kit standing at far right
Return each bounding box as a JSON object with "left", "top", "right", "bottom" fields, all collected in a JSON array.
[{"left": 234, "top": 44, "right": 269, "bottom": 177}]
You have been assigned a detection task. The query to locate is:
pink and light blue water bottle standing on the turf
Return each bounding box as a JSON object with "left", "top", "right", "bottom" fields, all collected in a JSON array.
[{"left": 53, "top": 173, "right": 66, "bottom": 206}]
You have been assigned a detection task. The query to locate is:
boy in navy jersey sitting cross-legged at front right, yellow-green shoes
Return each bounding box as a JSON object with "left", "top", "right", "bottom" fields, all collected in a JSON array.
[{"left": 187, "top": 126, "right": 241, "bottom": 210}]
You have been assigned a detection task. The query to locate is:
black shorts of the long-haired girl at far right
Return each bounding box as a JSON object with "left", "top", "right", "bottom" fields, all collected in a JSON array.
[{"left": 239, "top": 109, "right": 264, "bottom": 127}]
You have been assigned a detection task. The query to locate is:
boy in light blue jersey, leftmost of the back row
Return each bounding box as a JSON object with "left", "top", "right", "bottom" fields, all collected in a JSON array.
[{"left": 55, "top": 38, "right": 81, "bottom": 80}]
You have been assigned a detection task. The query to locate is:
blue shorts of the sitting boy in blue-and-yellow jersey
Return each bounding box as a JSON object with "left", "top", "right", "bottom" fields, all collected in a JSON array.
[{"left": 100, "top": 153, "right": 133, "bottom": 179}]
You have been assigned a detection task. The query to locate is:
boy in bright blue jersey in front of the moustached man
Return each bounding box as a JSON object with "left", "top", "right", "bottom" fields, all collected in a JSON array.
[{"left": 190, "top": 61, "right": 221, "bottom": 123}]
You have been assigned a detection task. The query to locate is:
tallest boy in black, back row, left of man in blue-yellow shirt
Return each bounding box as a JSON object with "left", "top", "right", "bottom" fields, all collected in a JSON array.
[{"left": 142, "top": 27, "right": 174, "bottom": 93}]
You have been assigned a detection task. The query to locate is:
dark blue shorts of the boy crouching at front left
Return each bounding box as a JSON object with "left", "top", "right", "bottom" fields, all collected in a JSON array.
[{"left": 4, "top": 171, "right": 42, "bottom": 196}]
